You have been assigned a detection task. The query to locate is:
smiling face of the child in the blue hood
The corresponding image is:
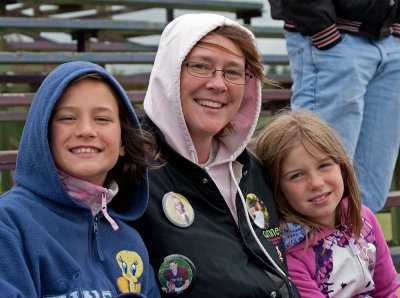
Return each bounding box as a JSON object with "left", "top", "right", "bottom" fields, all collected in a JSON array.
[{"left": 49, "top": 79, "right": 125, "bottom": 185}]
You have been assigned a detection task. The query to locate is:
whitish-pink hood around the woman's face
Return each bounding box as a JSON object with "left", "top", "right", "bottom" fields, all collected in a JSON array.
[{"left": 144, "top": 14, "right": 261, "bottom": 217}]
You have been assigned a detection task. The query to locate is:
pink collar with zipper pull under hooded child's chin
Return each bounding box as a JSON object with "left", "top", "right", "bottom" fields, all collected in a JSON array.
[{"left": 57, "top": 169, "right": 118, "bottom": 231}]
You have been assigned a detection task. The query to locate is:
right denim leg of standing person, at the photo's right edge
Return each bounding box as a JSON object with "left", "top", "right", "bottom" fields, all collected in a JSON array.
[{"left": 355, "top": 37, "right": 400, "bottom": 212}]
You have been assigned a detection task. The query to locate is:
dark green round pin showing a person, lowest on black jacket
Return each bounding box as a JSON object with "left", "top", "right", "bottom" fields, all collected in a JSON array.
[{"left": 158, "top": 254, "right": 196, "bottom": 294}]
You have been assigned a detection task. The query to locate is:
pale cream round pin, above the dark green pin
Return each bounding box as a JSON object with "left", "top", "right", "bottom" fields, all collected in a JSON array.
[{"left": 162, "top": 191, "right": 194, "bottom": 228}]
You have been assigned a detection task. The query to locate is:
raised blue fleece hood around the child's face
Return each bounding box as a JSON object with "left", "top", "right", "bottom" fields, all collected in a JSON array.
[{"left": 15, "top": 62, "right": 148, "bottom": 220}]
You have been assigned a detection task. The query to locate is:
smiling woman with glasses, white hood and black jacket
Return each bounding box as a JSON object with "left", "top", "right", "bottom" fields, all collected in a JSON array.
[{"left": 135, "top": 14, "right": 299, "bottom": 298}]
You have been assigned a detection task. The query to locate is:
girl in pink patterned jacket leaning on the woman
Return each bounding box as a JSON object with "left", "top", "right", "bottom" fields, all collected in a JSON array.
[{"left": 255, "top": 110, "right": 400, "bottom": 298}]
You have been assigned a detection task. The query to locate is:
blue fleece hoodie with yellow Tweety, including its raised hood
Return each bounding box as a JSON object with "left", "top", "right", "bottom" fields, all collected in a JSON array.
[{"left": 0, "top": 62, "right": 160, "bottom": 297}]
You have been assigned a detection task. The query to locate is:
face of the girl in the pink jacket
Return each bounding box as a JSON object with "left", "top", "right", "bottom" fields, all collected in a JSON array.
[{"left": 279, "top": 143, "right": 344, "bottom": 226}]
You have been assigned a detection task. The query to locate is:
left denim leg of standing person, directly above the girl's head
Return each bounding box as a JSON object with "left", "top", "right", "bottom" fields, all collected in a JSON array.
[{"left": 286, "top": 32, "right": 380, "bottom": 159}]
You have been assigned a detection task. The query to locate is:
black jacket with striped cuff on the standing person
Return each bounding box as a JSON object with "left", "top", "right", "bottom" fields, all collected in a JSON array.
[{"left": 268, "top": 0, "right": 400, "bottom": 50}]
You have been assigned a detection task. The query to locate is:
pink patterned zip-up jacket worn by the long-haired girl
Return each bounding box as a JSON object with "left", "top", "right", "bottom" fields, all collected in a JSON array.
[{"left": 286, "top": 204, "right": 400, "bottom": 298}]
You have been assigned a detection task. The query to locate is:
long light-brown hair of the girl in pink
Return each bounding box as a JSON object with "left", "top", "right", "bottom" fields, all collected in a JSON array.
[{"left": 254, "top": 110, "right": 363, "bottom": 244}]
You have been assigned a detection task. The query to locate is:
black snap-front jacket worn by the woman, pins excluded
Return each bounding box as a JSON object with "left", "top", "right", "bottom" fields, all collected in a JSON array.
[{"left": 134, "top": 119, "right": 300, "bottom": 298}]
